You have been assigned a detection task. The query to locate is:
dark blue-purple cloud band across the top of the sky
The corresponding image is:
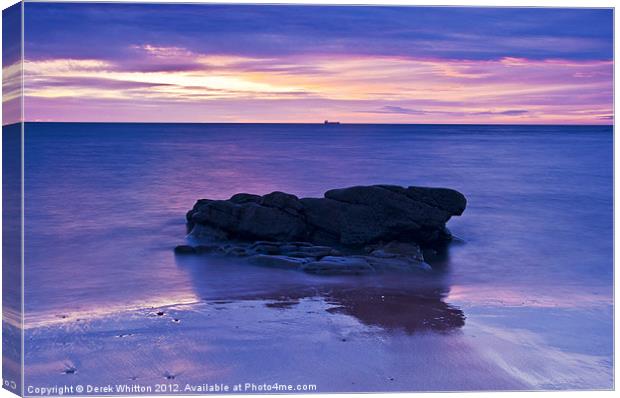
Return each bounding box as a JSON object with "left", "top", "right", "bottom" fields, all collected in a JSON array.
[{"left": 26, "top": 3, "right": 613, "bottom": 60}]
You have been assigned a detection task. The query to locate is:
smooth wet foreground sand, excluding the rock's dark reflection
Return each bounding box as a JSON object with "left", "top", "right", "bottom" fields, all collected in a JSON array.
[{"left": 26, "top": 290, "right": 613, "bottom": 392}]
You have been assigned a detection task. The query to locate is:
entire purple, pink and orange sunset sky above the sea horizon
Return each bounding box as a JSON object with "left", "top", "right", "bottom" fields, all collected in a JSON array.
[{"left": 3, "top": 3, "right": 613, "bottom": 124}]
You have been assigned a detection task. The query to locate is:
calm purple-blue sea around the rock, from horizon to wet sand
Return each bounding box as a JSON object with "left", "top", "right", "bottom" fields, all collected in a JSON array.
[{"left": 25, "top": 123, "right": 613, "bottom": 390}]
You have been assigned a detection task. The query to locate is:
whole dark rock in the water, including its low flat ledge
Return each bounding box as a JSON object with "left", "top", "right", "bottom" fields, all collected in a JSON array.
[{"left": 175, "top": 185, "right": 467, "bottom": 274}]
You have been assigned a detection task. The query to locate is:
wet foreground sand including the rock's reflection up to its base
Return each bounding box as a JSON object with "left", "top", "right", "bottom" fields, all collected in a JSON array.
[{"left": 26, "top": 257, "right": 612, "bottom": 393}]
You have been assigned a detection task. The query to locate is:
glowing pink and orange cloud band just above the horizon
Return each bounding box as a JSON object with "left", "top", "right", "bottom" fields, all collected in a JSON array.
[{"left": 17, "top": 44, "right": 613, "bottom": 123}]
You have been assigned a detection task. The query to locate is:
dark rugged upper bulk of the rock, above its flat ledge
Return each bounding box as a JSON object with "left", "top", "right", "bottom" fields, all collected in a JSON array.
[{"left": 187, "top": 185, "right": 467, "bottom": 247}]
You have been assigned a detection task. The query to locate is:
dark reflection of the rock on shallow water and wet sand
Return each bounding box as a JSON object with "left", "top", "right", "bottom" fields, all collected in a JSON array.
[{"left": 176, "top": 247, "right": 465, "bottom": 334}]
